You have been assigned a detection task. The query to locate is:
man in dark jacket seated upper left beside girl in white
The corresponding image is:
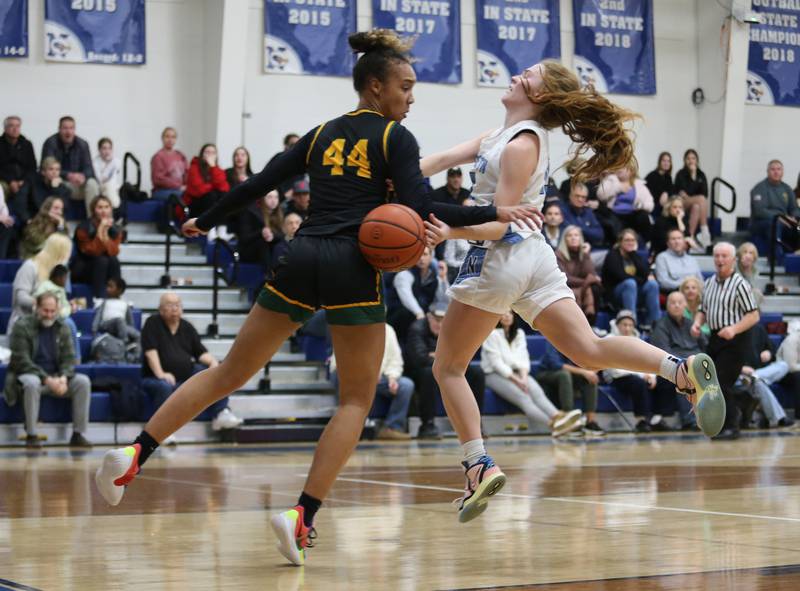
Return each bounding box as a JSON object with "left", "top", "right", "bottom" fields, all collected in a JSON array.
[{"left": 42, "top": 115, "right": 100, "bottom": 215}]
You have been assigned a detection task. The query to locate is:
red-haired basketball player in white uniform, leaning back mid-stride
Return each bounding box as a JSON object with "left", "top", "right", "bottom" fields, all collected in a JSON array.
[{"left": 421, "top": 61, "right": 725, "bottom": 522}]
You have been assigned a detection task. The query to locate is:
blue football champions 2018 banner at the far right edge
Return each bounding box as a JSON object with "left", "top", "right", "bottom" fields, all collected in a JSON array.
[{"left": 747, "top": 0, "right": 800, "bottom": 107}]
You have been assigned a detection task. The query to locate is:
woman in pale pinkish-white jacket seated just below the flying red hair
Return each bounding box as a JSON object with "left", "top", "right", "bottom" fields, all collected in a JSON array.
[{"left": 597, "top": 167, "right": 653, "bottom": 242}]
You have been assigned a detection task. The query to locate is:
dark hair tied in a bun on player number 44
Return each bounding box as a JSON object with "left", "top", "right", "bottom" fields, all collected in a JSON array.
[{"left": 347, "top": 29, "right": 414, "bottom": 93}]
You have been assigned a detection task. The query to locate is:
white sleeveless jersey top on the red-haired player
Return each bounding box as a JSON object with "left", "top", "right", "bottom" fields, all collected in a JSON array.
[{"left": 470, "top": 120, "right": 550, "bottom": 240}]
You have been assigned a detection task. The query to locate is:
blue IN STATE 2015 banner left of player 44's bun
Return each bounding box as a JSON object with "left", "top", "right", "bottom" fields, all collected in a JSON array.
[{"left": 264, "top": 0, "right": 356, "bottom": 76}]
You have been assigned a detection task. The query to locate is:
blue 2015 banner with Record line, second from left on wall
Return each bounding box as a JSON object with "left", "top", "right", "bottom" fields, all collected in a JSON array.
[{"left": 44, "top": 0, "right": 146, "bottom": 66}]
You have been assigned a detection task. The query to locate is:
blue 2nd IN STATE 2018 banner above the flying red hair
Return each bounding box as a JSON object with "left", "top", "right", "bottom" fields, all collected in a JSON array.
[{"left": 572, "top": 0, "right": 656, "bottom": 94}]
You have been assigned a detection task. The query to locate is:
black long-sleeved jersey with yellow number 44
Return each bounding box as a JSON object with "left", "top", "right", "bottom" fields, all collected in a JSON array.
[{"left": 197, "top": 109, "right": 497, "bottom": 236}]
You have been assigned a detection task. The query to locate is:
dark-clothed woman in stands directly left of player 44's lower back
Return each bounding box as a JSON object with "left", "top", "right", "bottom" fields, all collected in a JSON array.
[{"left": 236, "top": 190, "right": 283, "bottom": 270}]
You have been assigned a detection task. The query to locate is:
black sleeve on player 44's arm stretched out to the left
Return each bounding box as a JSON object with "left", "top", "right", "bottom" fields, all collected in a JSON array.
[{"left": 197, "top": 128, "right": 318, "bottom": 232}]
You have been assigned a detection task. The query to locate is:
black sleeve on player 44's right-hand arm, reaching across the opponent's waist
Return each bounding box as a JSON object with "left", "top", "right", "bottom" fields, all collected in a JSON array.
[{"left": 386, "top": 124, "right": 497, "bottom": 228}]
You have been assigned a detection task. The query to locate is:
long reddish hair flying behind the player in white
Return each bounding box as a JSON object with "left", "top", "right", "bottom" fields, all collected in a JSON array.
[{"left": 528, "top": 61, "right": 639, "bottom": 182}]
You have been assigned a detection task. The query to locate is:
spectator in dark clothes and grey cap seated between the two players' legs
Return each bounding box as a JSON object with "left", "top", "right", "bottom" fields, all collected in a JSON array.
[{"left": 406, "top": 301, "right": 486, "bottom": 439}]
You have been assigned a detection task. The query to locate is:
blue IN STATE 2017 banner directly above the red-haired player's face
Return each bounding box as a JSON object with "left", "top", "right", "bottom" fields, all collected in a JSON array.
[{"left": 475, "top": 0, "right": 561, "bottom": 88}]
